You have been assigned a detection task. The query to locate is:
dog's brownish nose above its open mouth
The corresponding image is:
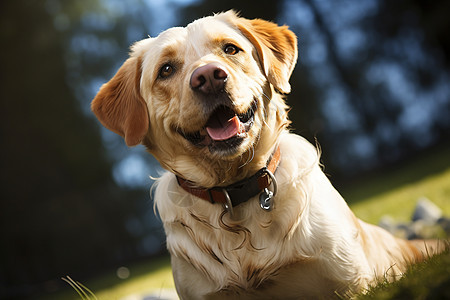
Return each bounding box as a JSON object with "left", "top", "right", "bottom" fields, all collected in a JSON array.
[{"left": 190, "top": 63, "right": 228, "bottom": 95}]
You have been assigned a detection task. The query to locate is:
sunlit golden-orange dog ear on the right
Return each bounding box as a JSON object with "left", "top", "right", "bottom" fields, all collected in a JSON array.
[{"left": 235, "top": 18, "right": 297, "bottom": 94}]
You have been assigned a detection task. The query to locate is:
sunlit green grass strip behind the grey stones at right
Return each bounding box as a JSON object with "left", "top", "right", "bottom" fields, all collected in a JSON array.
[{"left": 339, "top": 147, "right": 450, "bottom": 224}]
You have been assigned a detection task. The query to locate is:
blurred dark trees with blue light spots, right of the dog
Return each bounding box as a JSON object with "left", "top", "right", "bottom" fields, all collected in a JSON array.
[{"left": 280, "top": 0, "right": 450, "bottom": 178}]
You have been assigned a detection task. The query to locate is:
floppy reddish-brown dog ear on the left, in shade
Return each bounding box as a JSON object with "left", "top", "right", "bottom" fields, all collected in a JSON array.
[{"left": 91, "top": 57, "right": 149, "bottom": 146}]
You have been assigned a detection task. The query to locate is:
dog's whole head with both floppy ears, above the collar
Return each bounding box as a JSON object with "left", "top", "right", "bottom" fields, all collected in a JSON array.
[{"left": 92, "top": 11, "right": 297, "bottom": 185}]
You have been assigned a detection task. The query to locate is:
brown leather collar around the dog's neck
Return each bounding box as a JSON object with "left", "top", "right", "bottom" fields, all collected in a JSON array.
[{"left": 177, "top": 146, "right": 281, "bottom": 209}]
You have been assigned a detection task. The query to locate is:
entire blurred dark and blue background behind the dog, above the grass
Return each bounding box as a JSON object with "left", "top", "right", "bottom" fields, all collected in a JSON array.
[{"left": 0, "top": 0, "right": 450, "bottom": 299}]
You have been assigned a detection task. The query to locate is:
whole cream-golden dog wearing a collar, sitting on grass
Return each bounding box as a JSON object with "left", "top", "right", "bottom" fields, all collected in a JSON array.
[{"left": 92, "top": 11, "right": 444, "bottom": 299}]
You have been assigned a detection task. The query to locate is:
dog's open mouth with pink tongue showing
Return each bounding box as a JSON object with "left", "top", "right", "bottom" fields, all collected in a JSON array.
[{"left": 178, "top": 101, "right": 256, "bottom": 150}]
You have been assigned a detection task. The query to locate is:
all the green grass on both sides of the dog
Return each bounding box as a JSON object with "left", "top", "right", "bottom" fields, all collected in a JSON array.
[{"left": 42, "top": 148, "right": 450, "bottom": 300}]
